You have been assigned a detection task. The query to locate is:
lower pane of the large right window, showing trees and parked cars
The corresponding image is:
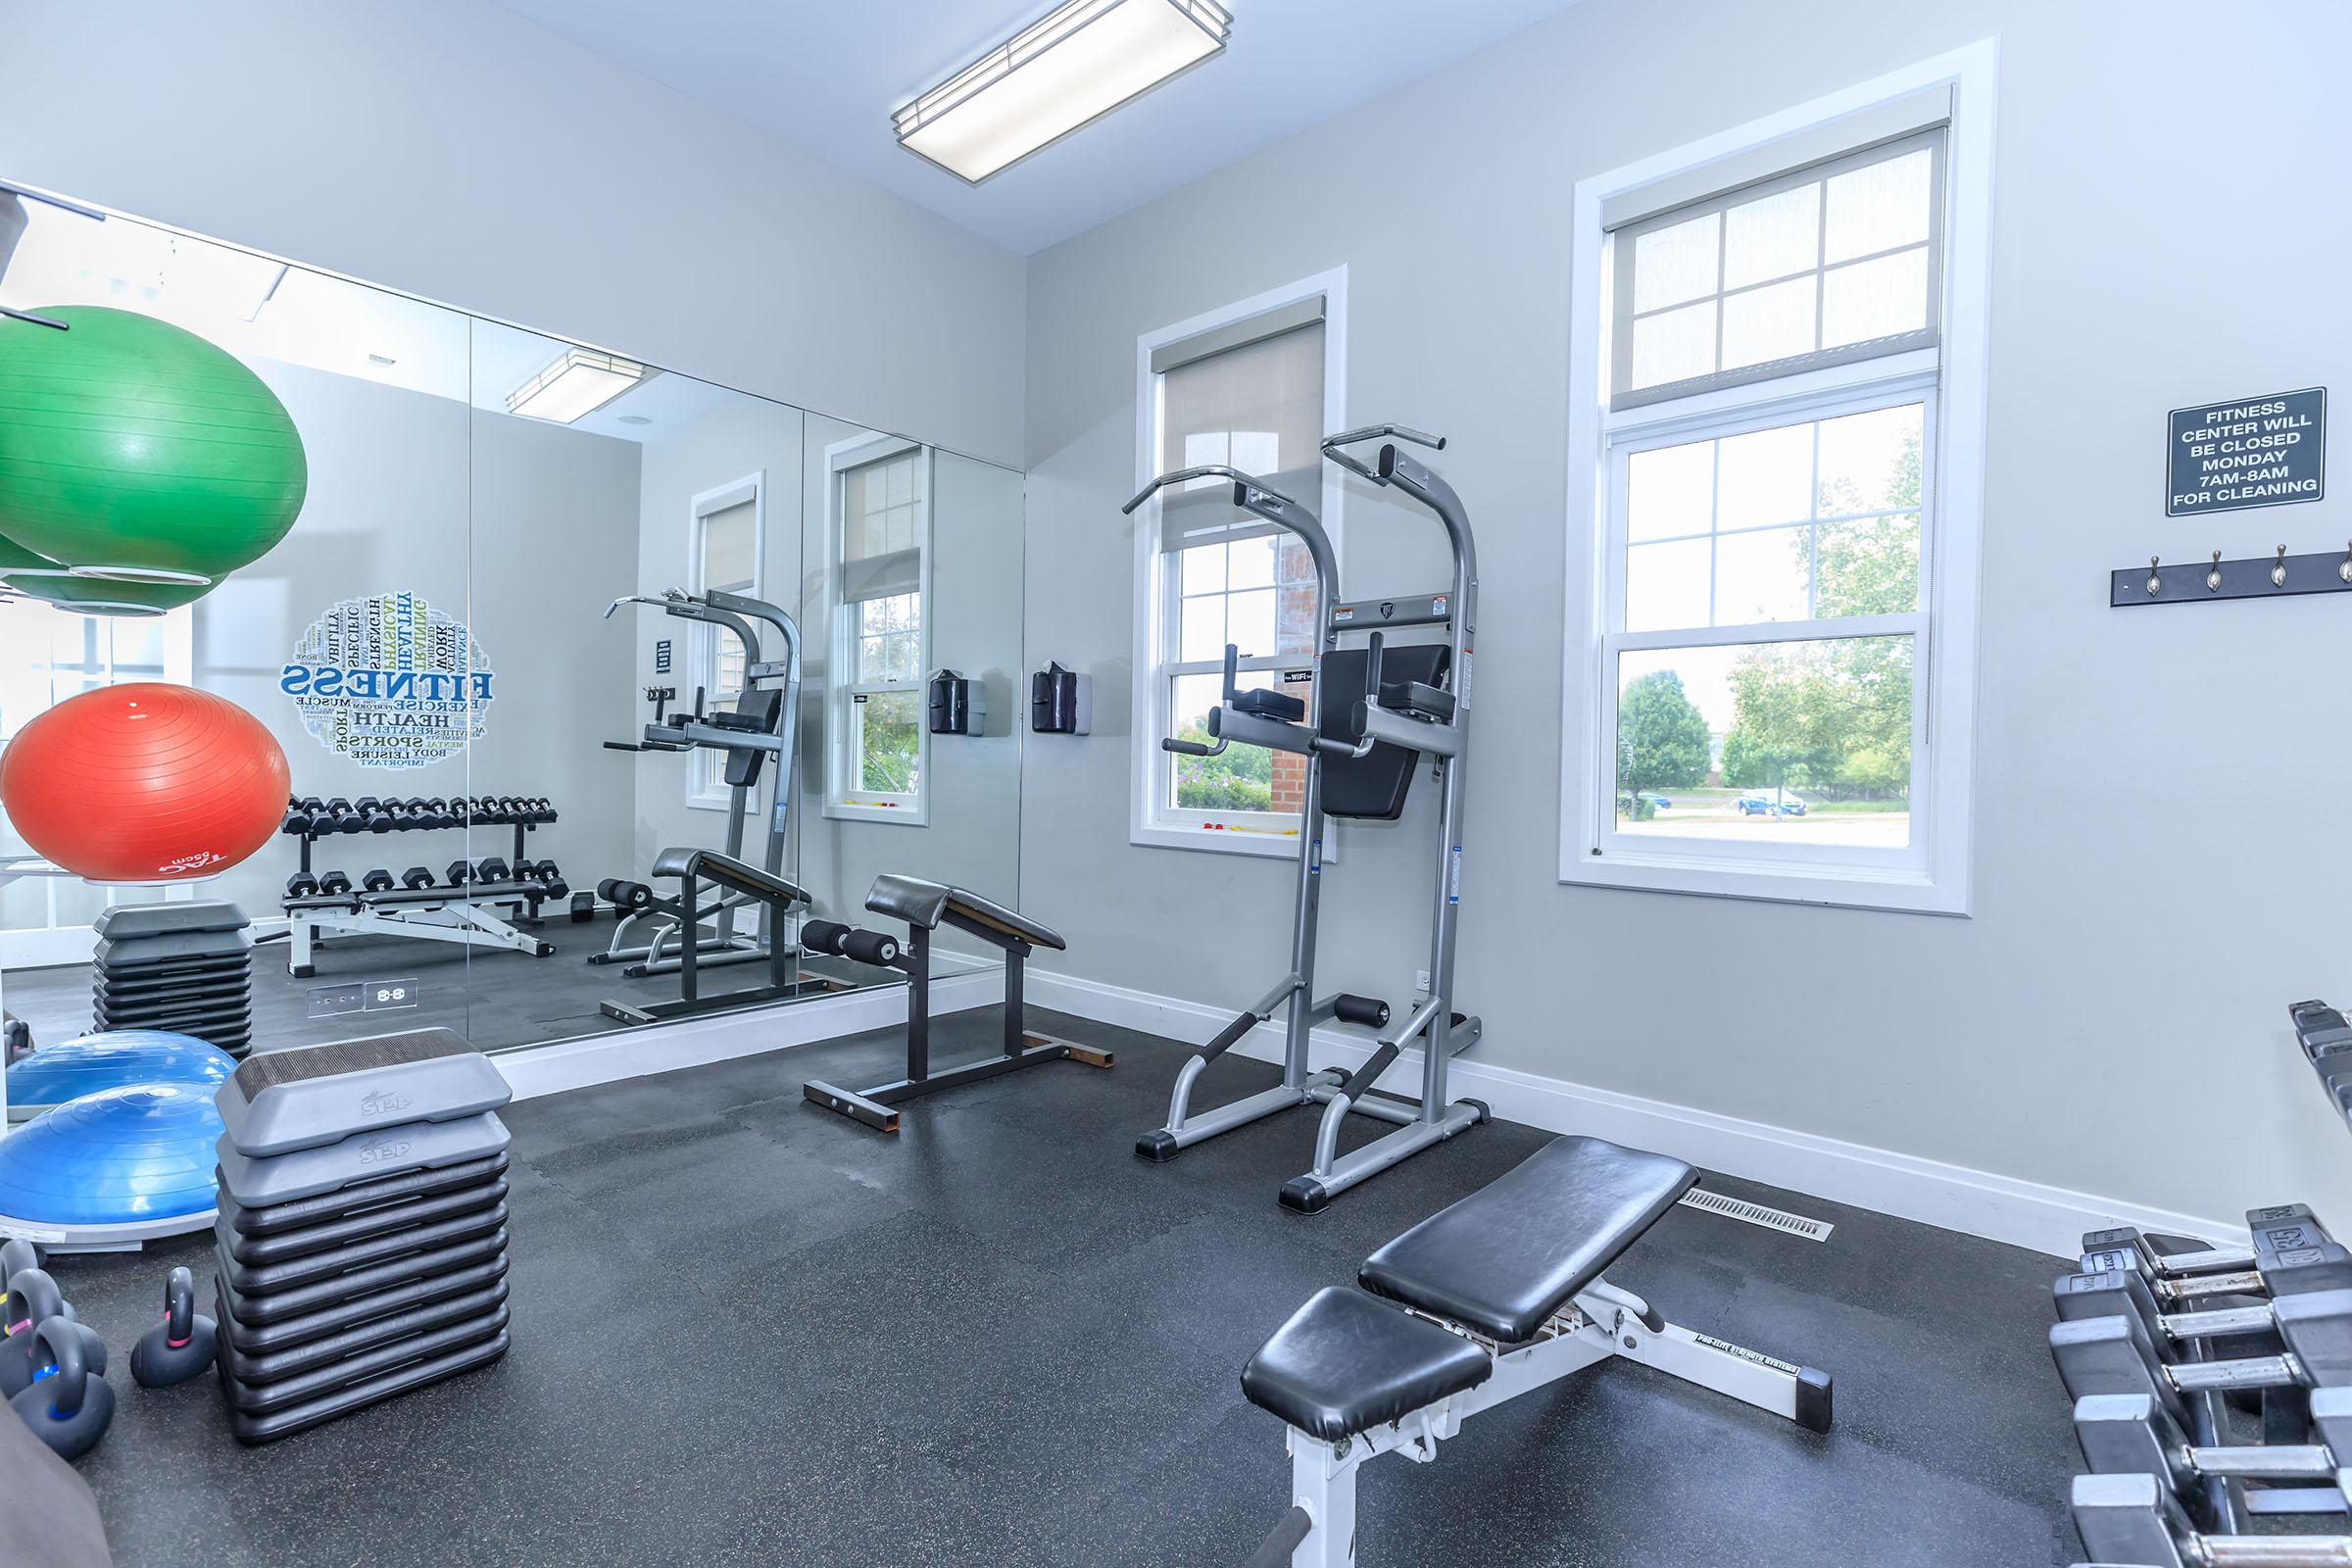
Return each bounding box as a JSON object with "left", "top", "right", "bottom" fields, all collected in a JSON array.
[{"left": 1616, "top": 637, "right": 1912, "bottom": 849}]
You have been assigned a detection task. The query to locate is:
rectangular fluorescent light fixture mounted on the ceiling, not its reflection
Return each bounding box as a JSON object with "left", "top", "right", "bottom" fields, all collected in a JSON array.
[{"left": 894, "top": 0, "right": 1233, "bottom": 186}]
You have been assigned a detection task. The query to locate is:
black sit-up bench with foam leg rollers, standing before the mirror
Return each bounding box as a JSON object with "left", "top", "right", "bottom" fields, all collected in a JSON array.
[{"left": 800, "top": 874, "right": 1110, "bottom": 1133}]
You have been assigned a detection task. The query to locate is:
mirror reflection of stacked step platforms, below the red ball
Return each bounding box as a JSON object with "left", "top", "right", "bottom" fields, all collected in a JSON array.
[{"left": 89, "top": 901, "right": 254, "bottom": 1057}]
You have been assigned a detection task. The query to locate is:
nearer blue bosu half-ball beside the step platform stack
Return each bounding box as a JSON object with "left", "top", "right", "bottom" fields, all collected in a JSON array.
[{"left": 0, "top": 1084, "right": 221, "bottom": 1250}]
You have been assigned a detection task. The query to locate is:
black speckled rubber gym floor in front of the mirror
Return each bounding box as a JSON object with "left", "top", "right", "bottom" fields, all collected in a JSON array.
[{"left": 41, "top": 1013, "right": 2077, "bottom": 1568}]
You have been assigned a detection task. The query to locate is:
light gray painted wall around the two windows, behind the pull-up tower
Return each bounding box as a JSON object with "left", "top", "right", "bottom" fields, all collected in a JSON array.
[{"left": 1021, "top": 0, "right": 2352, "bottom": 1218}]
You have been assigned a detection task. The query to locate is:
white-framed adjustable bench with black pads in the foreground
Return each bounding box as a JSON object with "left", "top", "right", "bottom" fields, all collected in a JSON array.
[{"left": 1242, "top": 1138, "right": 1830, "bottom": 1568}]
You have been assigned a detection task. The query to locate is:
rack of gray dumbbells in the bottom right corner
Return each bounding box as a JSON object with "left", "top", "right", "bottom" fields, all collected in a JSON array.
[{"left": 2051, "top": 1203, "right": 2352, "bottom": 1568}]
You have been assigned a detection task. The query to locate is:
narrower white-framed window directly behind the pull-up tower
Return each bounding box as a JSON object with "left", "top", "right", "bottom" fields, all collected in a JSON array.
[{"left": 1129, "top": 268, "right": 1348, "bottom": 856}]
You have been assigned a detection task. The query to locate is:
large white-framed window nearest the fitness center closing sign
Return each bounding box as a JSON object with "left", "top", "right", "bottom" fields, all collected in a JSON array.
[{"left": 1559, "top": 42, "right": 1997, "bottom": 914}]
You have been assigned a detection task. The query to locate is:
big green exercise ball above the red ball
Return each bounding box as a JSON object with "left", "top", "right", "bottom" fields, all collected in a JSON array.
[{"left": 0, "top": 306, "right": 311, "bottom": 585}]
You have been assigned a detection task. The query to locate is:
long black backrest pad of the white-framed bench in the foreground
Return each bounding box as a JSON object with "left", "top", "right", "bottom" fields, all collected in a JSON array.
[{"left": 1357, "top": 1138, "right": 1698, "bottom": 1345}]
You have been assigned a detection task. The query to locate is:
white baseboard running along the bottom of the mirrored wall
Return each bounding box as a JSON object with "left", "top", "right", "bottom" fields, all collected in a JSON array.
[{"left": 489, "top": 968, "right": 1004, "bottom": 1101}]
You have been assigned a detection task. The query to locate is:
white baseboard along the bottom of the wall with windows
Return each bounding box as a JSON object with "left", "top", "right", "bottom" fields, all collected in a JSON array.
[{"left": 1028, "top": 971, "right": 2246, "bottom": 1257}]
